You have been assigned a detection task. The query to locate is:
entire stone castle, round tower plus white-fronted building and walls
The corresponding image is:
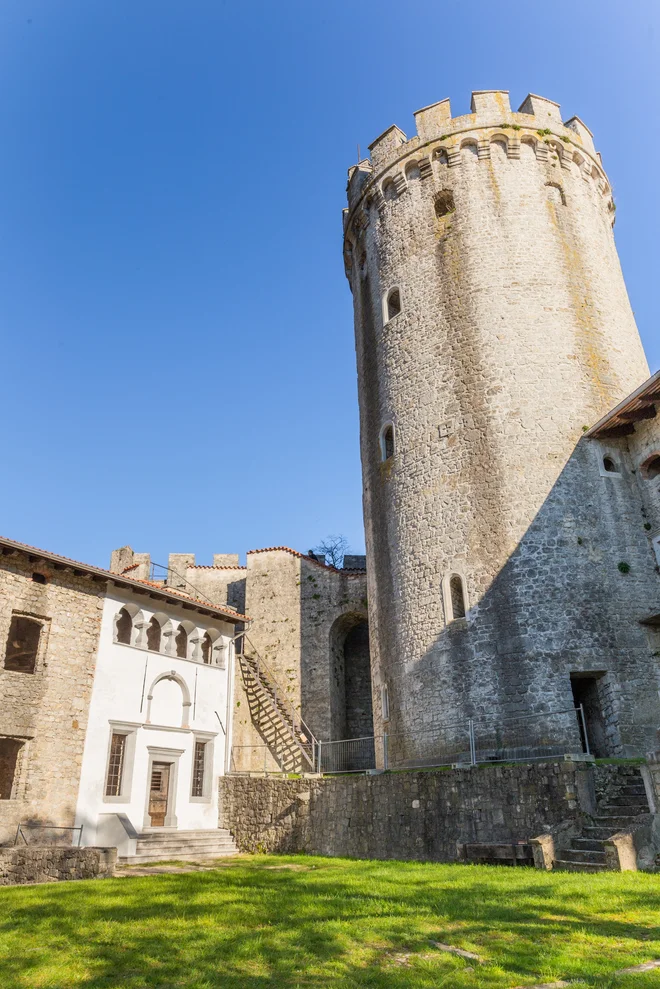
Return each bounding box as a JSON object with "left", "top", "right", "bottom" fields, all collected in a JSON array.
[{"left": 0, "top": 91, "right": 660, "bottom": 858}]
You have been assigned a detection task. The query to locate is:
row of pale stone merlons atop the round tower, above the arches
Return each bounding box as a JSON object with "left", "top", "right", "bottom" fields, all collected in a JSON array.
[{"left": 356, "top": 89, "right": 596, "bottom": 183}]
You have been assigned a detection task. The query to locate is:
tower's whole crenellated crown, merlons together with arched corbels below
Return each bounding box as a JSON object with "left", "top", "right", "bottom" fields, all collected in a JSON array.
[{"left": 344, "top": 90, "right": 614, "bottom": 270}]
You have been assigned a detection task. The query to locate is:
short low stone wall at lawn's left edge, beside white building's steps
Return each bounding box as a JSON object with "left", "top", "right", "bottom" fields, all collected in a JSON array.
[{"left": 0, "top": 845, "right": 117, "bottom": 886}]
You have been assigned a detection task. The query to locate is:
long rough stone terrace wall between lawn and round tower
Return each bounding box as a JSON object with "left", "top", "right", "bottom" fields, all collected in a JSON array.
[{"left": 219, "top": 762, "right": 596, "bottom": 862}]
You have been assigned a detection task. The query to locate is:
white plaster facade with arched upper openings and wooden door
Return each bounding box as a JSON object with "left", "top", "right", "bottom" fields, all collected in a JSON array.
[{"left": 76, "top": 589, "right": 233, "bottom": 845}]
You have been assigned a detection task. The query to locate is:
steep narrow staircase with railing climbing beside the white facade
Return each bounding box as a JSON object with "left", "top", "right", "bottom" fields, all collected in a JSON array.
[{"left": 238, "top": 636, "right": 317, "bottom": 773}]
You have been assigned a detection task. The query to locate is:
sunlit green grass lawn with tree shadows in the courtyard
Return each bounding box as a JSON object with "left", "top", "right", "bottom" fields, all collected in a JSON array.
[{"left": 0, "top": 856, "right": 660, "bottom": 989}]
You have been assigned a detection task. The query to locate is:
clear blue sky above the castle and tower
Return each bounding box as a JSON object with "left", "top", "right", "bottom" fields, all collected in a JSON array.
[{"left": 0, "top": 0, "right": 660, "bottom": 566}]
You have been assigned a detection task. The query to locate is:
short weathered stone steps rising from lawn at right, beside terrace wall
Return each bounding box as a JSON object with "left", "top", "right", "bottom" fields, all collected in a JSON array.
[{"left": 553, "top": 770, "right": 649, "bottom": 872}]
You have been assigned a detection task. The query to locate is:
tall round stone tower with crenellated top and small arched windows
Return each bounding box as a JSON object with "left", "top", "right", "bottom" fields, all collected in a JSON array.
[{"left": 344, "top": 91, "right": 660, "bottom": 757}]
